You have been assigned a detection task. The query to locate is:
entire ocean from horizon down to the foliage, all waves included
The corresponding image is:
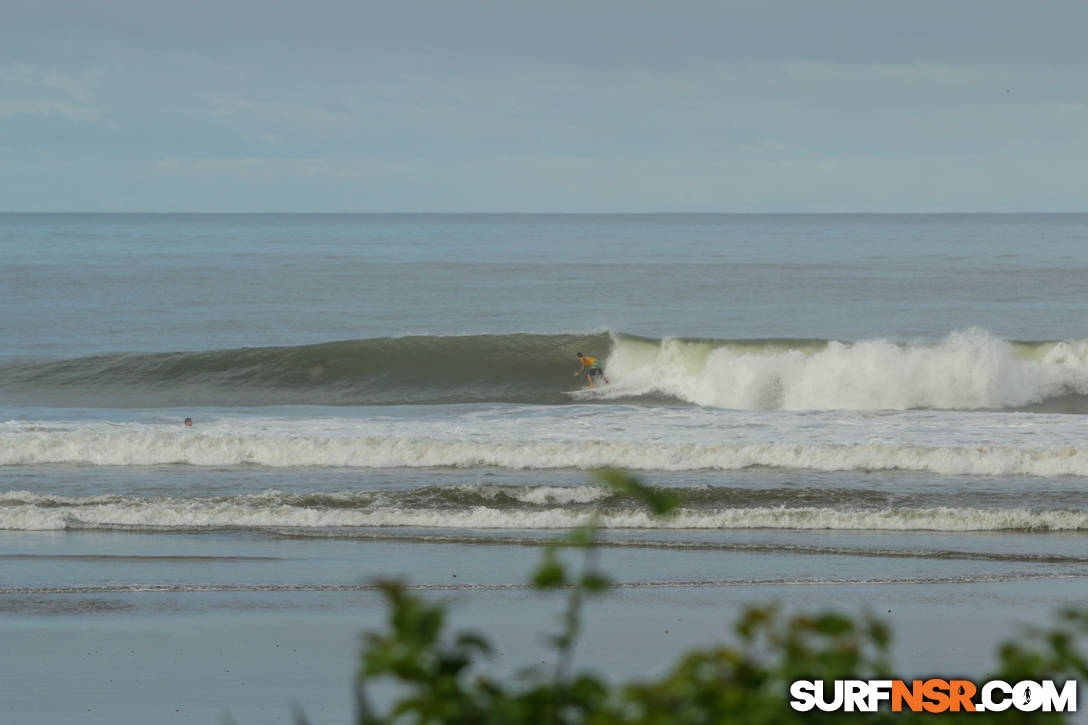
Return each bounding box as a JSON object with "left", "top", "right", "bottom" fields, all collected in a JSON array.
[{"left": 0, "top": 213, "right": 1088, "bottom": 725}]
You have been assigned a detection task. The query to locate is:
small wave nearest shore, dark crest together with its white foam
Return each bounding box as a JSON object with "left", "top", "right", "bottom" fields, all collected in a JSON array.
[{"left": 0, "top": 484, "right": 1088, "bottom": 536}]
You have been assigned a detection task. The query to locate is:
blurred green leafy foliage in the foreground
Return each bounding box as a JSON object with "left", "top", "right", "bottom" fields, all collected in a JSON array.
[{"left": 308, "top": 470, "right": 1088, "bottom": 725}]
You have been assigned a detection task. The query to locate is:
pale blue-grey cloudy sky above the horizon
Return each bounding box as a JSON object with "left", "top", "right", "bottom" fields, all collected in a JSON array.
[{"left": 0, "top": 0, "right": 1088, "bottom": 212}]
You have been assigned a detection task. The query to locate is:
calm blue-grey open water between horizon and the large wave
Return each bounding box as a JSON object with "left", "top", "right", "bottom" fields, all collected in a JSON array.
[{"left": 0, "top": 213, "right": 1088, "bottom": 359}]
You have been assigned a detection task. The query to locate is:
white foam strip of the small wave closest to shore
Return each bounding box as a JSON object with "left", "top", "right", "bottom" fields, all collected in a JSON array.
[{"left": 0, "top": 492, "right": 1088, "bottom": 531}]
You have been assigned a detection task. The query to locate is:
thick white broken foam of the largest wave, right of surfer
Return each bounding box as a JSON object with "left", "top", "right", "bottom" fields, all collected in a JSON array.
[{"left": 598, "top": 329, "right": 1088, "bottom": 410}]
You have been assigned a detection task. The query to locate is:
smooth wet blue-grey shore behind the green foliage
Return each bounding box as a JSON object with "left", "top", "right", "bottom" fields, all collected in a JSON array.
[{"left": 0, "top": 579, "right": 1088, "bottom": 725}]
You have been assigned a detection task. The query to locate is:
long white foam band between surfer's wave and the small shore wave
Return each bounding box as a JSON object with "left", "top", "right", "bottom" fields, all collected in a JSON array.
[{"left": 0, "top": 430, "right": 1088, "bottom": 476}]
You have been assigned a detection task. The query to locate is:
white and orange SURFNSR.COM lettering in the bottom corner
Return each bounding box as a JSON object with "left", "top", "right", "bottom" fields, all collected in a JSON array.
[{"left": 790, "top": 678, "right": 1077, "bottom": 713}]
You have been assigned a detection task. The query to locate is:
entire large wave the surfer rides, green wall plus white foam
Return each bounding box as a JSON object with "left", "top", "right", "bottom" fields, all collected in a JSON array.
[{"left": 6, "top": 329, "right": 1088, "bottom": 413}]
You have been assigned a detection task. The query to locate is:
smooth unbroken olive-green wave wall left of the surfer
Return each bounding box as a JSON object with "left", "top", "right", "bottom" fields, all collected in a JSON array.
[{"left": 0, "top": 333, "right": 610, "bottom": 407}]
